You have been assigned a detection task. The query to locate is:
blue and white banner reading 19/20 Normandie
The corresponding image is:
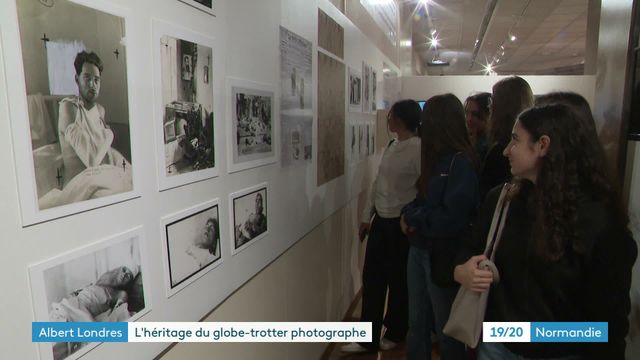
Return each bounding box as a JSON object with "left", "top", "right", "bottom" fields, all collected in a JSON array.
[{"left": 482, "top": 322, "right": 609, "bottom": 343}]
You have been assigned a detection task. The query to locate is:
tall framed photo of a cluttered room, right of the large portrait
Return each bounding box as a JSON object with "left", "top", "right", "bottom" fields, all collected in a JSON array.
[{"left": 152, "top": 19, "right": 219, "bottom": 191}]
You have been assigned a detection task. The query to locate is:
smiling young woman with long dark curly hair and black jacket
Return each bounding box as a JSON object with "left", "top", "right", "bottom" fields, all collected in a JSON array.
[{"left": 454, "top": 104, "right": 637, "bottom": 360}]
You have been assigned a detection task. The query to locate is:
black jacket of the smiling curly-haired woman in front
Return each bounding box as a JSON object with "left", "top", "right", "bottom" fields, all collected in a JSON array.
[{"left": 458, "top": 184, "right": 637, "bottom": 360}]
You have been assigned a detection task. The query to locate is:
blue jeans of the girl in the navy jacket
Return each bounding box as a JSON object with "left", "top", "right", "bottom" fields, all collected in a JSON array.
[{"left": 407, "top": 246, "right": 465, "bottom": 360}]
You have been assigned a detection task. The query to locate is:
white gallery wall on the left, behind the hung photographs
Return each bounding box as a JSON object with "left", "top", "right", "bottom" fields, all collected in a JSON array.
[{"left": 0, "top": 0, "right": 398, "bottom": 359}]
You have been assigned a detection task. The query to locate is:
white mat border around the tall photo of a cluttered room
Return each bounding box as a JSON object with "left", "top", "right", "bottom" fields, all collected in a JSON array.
[{"left": 151, "top": 18, "right": 222, "bottom": 191}]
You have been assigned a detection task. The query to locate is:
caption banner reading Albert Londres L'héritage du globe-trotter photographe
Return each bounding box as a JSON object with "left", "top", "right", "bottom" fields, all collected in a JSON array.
[{"left": 31, "top": 322, "right": 371, "bottom": 342}]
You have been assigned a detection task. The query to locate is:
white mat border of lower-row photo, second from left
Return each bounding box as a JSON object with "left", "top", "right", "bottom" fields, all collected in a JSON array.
[{"left": 160, "top": 198, "right": 224, "bottom": 299}]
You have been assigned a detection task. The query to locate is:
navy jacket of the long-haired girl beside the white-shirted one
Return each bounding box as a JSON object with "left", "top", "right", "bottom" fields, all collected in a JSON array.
[{"left": 402, "top": 153, "right": 479, "bottom": 249}]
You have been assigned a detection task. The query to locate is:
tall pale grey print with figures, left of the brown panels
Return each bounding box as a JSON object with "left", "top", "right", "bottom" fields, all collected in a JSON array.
[{"left": 280, "top": 26, "right": 314, "bottom": 167}]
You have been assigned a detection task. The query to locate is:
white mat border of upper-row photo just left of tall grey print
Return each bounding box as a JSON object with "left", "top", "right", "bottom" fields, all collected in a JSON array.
[{"left": 226, "top": 77, "right": 280, "bottom": 174}]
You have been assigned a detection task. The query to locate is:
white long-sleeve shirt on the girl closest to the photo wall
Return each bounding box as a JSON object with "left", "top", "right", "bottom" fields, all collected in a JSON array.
[{"left": 361, "top": 136, "right": 420, "bottom": 222}]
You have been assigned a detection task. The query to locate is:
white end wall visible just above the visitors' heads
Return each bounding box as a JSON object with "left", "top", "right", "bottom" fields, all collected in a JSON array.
[{"left": 401, "top": 75, "right": 596, "bottom": 106}]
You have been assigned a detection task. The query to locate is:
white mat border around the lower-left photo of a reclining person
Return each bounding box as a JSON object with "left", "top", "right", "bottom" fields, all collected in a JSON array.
[{"left": 27, "top": 225, "right": 153, "bottom": 360}]
